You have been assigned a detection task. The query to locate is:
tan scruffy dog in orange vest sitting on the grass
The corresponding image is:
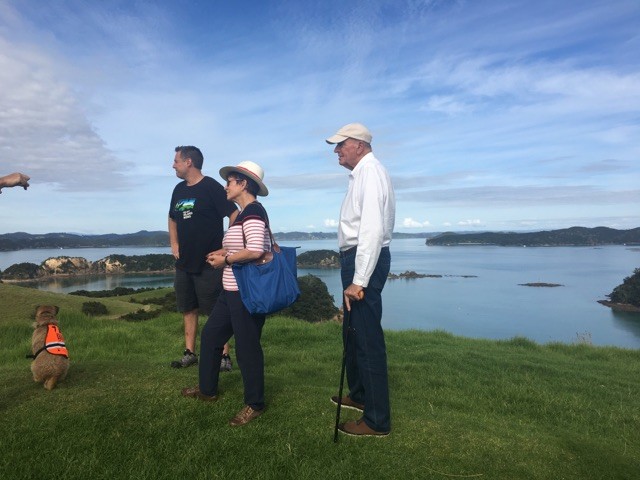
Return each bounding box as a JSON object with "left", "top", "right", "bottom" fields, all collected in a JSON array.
[{"left": 27, "top": 305, "right": 69, "bottom": 390}]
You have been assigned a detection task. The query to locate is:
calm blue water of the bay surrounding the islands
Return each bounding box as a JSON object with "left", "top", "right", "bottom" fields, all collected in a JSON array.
[{"left": 0, "top": 239, "right": 640, "bottom": 348}]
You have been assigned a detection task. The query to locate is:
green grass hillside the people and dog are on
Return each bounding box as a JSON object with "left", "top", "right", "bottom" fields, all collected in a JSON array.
[{"left": 0, "top": 284, "right": 640, "bottom": 480}]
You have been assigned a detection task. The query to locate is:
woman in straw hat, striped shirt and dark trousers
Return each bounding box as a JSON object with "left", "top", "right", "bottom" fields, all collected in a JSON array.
[{"left": 182, "top": 161, "right": 271, "bottom": 426}]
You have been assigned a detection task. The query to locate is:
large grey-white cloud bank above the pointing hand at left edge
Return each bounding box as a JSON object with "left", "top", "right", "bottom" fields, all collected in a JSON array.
[{"left": 0, "top": 33, "right": 128, "bottom": 192}]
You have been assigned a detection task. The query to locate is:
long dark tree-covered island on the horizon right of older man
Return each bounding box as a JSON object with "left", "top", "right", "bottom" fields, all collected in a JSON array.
[{"left": 426, "top": 227, "right": 640, "bottom": 247}]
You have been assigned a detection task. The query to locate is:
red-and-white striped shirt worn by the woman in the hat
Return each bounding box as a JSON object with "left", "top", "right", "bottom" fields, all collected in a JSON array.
[{"left": 222, "top": 202, "right": 271, "bottom": 292}]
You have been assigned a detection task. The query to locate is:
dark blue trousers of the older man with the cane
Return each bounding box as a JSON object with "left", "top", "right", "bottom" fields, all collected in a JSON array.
[{"left": 340, "top": 248, "right": 391, "bottom": 432}]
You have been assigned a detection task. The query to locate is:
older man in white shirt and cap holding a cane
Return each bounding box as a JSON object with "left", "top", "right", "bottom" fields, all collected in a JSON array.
[{"left": 326, "top": 123, "right": 396, "bottom": 435}]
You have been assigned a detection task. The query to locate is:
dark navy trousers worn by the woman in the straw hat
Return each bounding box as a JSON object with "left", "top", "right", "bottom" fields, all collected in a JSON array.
[{"left": 198, "top": 290, "right": 265, "bottom": 410}]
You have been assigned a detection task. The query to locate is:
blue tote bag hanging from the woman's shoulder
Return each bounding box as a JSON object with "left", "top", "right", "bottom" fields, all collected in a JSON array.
[{"left": 231, "top": 206, "right": 300, "bottom": 315}]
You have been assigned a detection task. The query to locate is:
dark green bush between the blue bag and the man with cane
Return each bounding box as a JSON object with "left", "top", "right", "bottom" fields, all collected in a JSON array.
[{"left": 278, "top": 274, "right": 339, "bottom": 322}]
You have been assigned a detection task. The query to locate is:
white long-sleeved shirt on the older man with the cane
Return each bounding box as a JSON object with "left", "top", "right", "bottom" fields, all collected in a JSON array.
[{"left": 338, "top": 152, "right": 396, "bottom": 287}]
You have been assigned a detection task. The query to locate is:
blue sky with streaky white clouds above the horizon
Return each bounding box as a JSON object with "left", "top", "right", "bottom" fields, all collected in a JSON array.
[{"left": 0, "top": 0, "right": 640, "bottom": 234}]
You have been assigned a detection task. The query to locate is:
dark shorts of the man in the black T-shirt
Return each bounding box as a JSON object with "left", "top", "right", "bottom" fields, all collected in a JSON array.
[{"left": 173, "top": 265, "right": 222, "bottom": 316}]
